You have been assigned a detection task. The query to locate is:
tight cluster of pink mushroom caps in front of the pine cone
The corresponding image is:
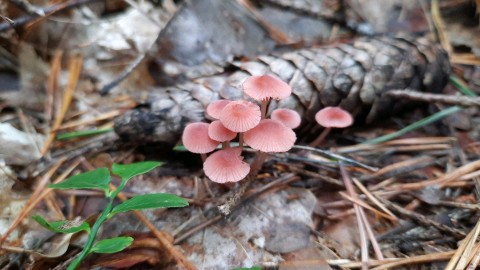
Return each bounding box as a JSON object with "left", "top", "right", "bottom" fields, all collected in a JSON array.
[{"left": 182, "top": 75, "right": 301, "bottom": 183}]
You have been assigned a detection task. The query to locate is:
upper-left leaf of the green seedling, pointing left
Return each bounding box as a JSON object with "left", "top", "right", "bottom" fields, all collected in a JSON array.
[{"left": 48, "top": 168, "right": 111, "bottom": 193}]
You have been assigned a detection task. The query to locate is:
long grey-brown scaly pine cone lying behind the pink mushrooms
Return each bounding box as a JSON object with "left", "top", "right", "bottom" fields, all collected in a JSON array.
[{"left": 115, "top": 37, "right": 450, "bottom": 146}]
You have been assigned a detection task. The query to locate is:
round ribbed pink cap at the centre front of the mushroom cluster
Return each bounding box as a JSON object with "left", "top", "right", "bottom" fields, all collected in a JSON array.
[{"left": 219, "top": 100, "right": 261, "bottom": 132}]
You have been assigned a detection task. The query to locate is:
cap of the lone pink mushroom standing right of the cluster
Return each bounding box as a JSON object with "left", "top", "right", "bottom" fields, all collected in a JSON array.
[{"left": 315, "top": 107, "right": 353, "bottom": 128}]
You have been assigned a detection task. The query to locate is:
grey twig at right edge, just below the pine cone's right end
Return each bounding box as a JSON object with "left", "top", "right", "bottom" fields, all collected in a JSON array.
[{"left": 386, "top": 90, "right": 480, "bottom": 107}]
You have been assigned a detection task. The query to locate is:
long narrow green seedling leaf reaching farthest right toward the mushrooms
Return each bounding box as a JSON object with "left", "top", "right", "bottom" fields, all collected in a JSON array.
[{"left": 111, "top": 193, "right": 188, "bottom": 215}]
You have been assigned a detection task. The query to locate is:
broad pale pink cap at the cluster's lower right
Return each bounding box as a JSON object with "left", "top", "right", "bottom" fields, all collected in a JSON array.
[{"left": 243, "top": 119, "right": 297, "bottom": 152}]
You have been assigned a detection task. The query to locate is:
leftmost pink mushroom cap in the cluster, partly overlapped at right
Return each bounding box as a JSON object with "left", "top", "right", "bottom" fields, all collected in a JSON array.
[{"left": 182, "top": 122, "right": 219, "bottom": 154}]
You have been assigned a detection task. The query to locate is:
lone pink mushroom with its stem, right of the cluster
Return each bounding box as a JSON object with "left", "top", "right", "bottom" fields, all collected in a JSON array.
[{"left": 310, "top": 107, "right": 353, "bottom": 147}]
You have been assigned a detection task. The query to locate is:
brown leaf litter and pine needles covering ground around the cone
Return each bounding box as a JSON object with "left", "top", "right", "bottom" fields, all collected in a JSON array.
[{"left": 0, "top": 0, "right": 480, "bottom": 269}]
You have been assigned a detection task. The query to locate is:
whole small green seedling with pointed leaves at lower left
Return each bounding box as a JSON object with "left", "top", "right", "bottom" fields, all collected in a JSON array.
[{"left": 32, "top": 161, "right": 188, "bottom": 270}]
